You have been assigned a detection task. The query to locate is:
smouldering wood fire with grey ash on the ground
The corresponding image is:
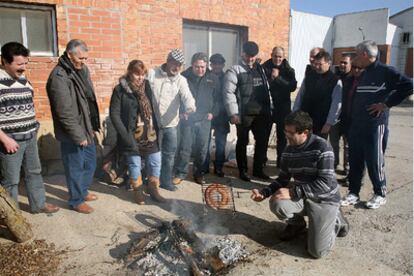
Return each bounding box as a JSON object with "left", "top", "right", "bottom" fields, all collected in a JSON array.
[{"left": 124, "top": 220, "right": 248, "bottom": 276}]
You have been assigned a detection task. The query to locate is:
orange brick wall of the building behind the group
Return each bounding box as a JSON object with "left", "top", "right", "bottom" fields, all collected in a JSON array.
[{"left": 6, "top": 0, "right": 290, "bottom": 172}]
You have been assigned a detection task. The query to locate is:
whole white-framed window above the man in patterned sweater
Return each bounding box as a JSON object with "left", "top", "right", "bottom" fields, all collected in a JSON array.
[{"left": 0, "top": 3, "right": 57, "bottom": 56}]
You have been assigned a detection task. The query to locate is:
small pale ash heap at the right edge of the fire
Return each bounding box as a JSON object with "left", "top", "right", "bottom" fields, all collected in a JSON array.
[{"left": 208, "top": 237, "right": 249, "bottom": 266}]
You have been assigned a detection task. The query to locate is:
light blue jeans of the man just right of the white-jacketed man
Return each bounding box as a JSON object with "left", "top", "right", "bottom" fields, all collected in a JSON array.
[{"left": 174, "top": 120, "right": 211, "bottom": 179}]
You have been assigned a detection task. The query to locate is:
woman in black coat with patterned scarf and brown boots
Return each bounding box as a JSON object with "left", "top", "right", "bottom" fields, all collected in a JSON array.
[{"left": 110, "top": 60, "right": 165, "bottom": 204}]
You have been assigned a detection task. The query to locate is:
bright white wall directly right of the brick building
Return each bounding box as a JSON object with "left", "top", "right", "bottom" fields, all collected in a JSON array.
[{"left": 289, "top": 10, "right": 332, "bottom": 85}]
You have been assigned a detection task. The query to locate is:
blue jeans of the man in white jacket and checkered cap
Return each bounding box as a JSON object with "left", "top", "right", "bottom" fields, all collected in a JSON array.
[{"left": 158, "top": 127, "right": 177, "bottom": 187}]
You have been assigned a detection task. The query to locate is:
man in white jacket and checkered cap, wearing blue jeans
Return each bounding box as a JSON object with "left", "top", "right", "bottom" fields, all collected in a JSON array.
[{"left": 148, "top": 49, "right": 196, "bottom": 191}]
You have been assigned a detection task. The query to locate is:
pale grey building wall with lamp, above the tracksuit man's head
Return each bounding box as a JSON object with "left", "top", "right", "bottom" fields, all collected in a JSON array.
[{"left": 333, "top": 8, "right": 389, "bottom": 48}]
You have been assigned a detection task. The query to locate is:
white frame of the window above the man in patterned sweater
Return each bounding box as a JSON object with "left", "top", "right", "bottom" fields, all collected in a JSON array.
[{"left": 0, "top": 2, "right": 58, "bottom": 57}]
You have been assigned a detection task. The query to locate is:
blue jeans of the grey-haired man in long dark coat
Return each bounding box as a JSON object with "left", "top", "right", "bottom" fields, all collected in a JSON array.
[{"left": 60, "top": 142, "right": 96, "bottom": 208}]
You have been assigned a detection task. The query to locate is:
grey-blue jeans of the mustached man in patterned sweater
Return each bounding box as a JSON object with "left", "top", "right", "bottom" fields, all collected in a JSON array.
[{"left": 0, "top": 136, "right": 45, "bottom": 212}]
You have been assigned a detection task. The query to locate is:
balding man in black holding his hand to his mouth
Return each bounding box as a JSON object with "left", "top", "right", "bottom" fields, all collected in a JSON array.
[{"left": 262, "top": 47, "right": 297, "bottom": 168}]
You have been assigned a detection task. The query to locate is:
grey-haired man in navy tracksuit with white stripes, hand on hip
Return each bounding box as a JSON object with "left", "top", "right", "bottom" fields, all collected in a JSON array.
[{"left": 341, "top": 40, "right": 413, "bottom": 209}]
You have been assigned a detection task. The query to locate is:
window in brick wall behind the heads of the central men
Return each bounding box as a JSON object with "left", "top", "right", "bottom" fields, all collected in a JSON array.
[{"left": 183, "top": 22, "right": 245, "bottom": 69}]
